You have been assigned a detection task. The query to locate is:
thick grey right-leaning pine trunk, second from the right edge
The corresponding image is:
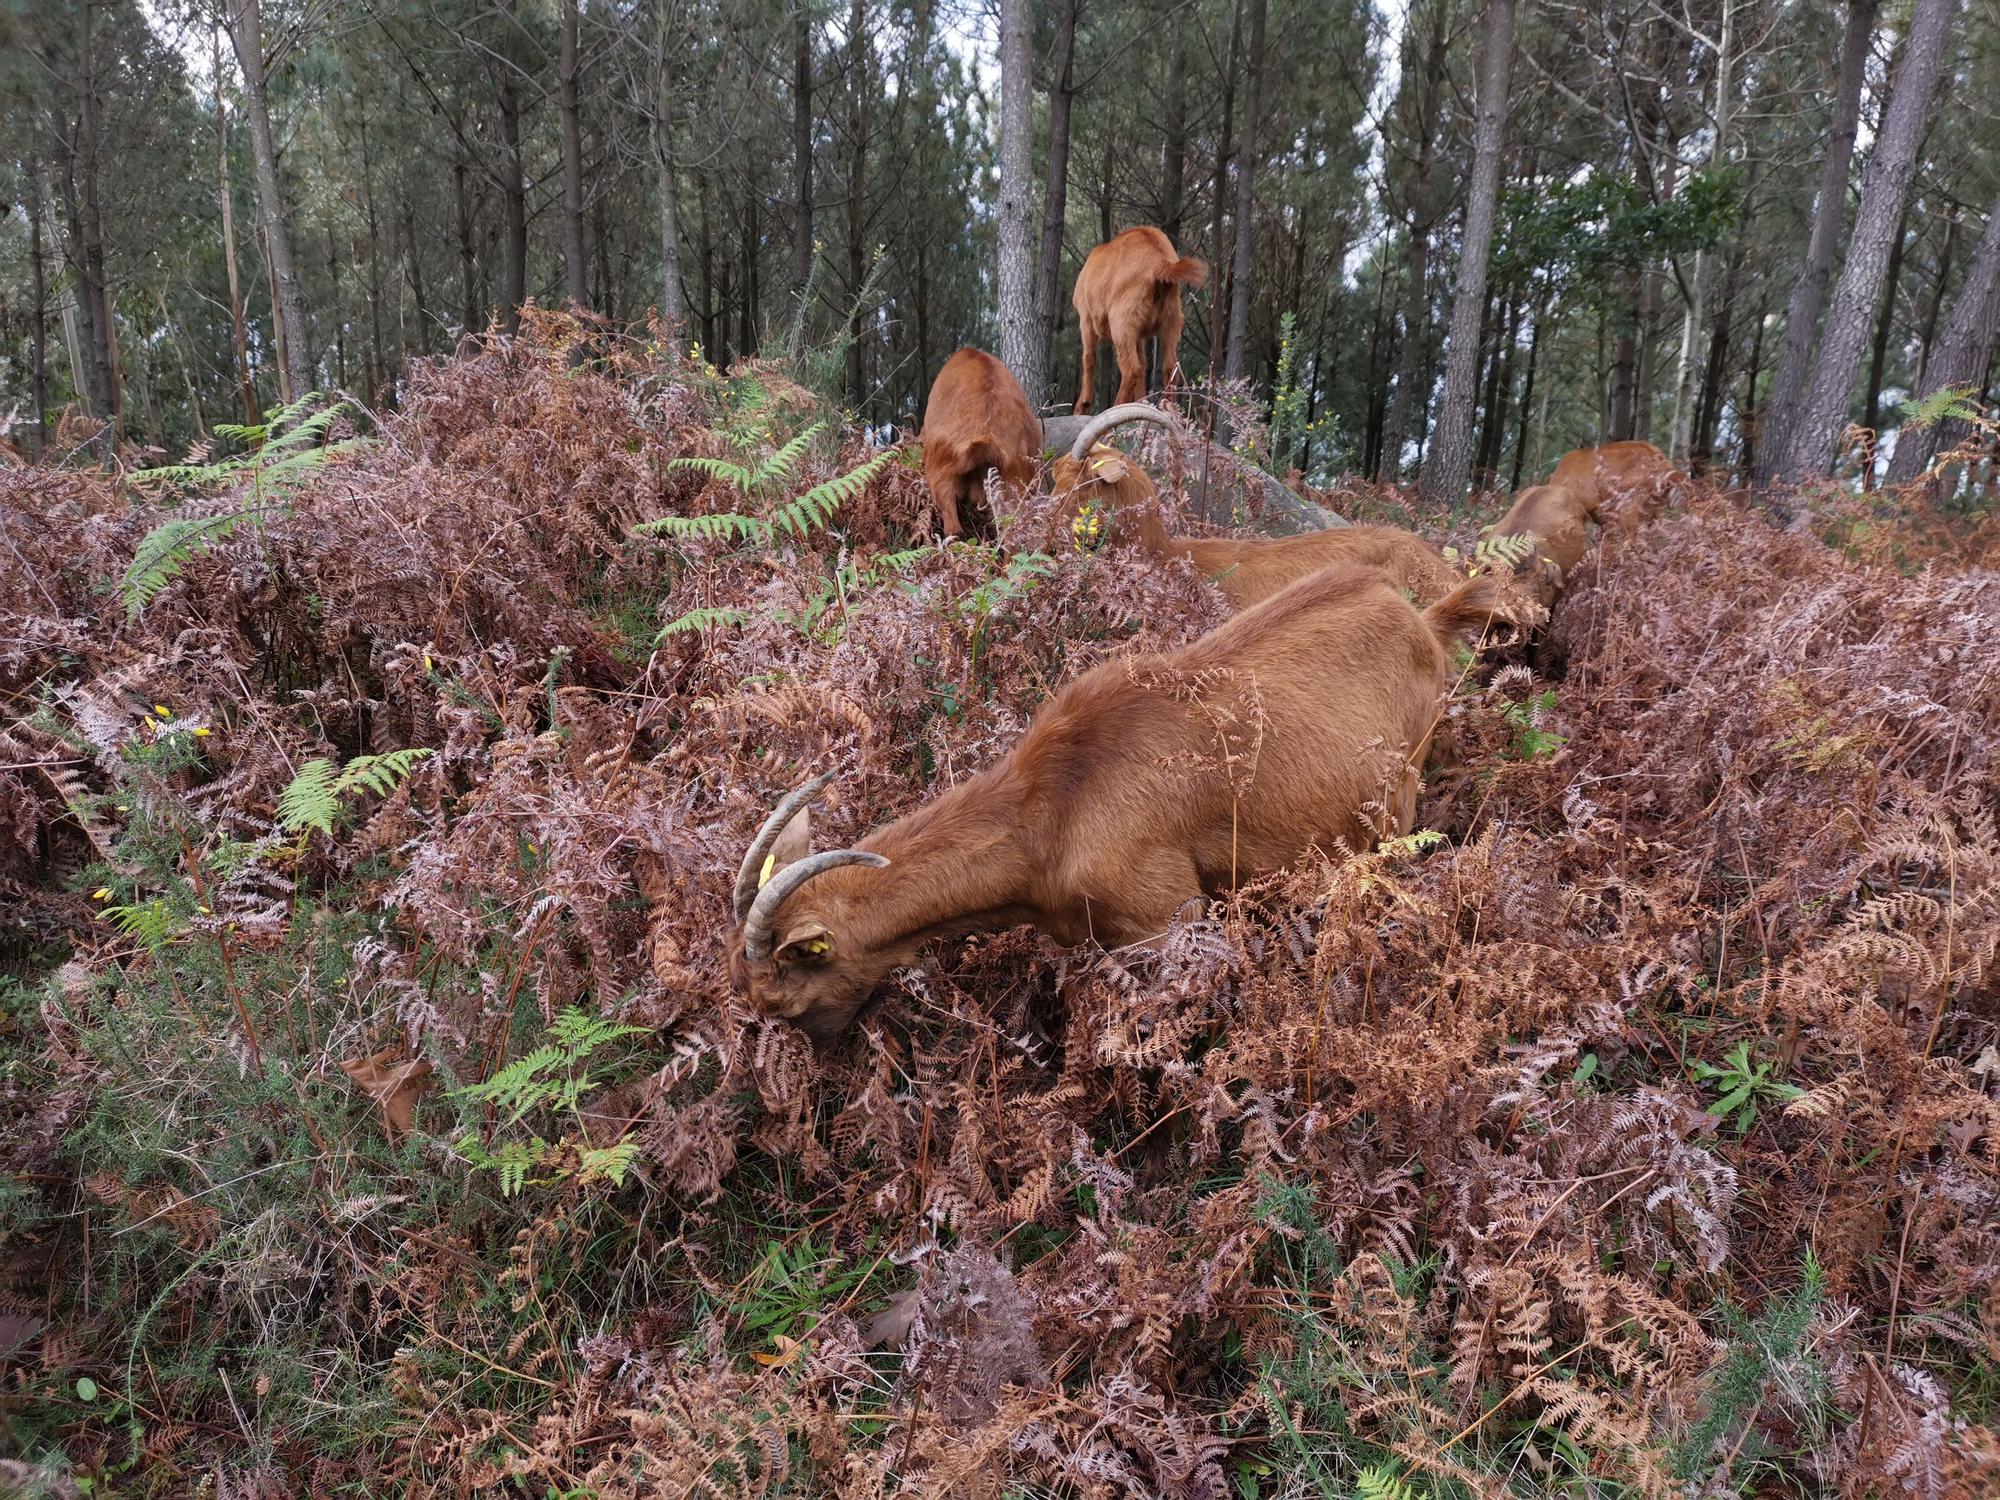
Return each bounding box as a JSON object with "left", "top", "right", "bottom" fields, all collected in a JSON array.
[{"left": 1778, "top": 0, "right": 1958, "bottom": 484}]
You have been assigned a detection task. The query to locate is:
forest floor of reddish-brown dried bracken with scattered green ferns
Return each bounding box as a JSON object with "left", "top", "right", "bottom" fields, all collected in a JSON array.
[{"left": 0, "top": 318, "right": 2000, "bottom": 1500}]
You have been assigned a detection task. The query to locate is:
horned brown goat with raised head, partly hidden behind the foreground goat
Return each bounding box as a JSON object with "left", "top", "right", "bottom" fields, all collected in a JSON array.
[{"left": 1052, "top": 404, "right": 1464, "bottom": 610}]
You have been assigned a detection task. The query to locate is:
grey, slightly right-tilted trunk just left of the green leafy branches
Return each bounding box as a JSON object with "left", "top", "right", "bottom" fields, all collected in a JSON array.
[{"left": 1420, "top": 0, "right": 1514, "bottom": 502}]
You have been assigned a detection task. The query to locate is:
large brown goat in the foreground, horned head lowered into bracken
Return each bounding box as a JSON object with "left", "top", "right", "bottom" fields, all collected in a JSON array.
[{"left": 730, "top": 568, "right": 1508, "bottom": 1038}]
